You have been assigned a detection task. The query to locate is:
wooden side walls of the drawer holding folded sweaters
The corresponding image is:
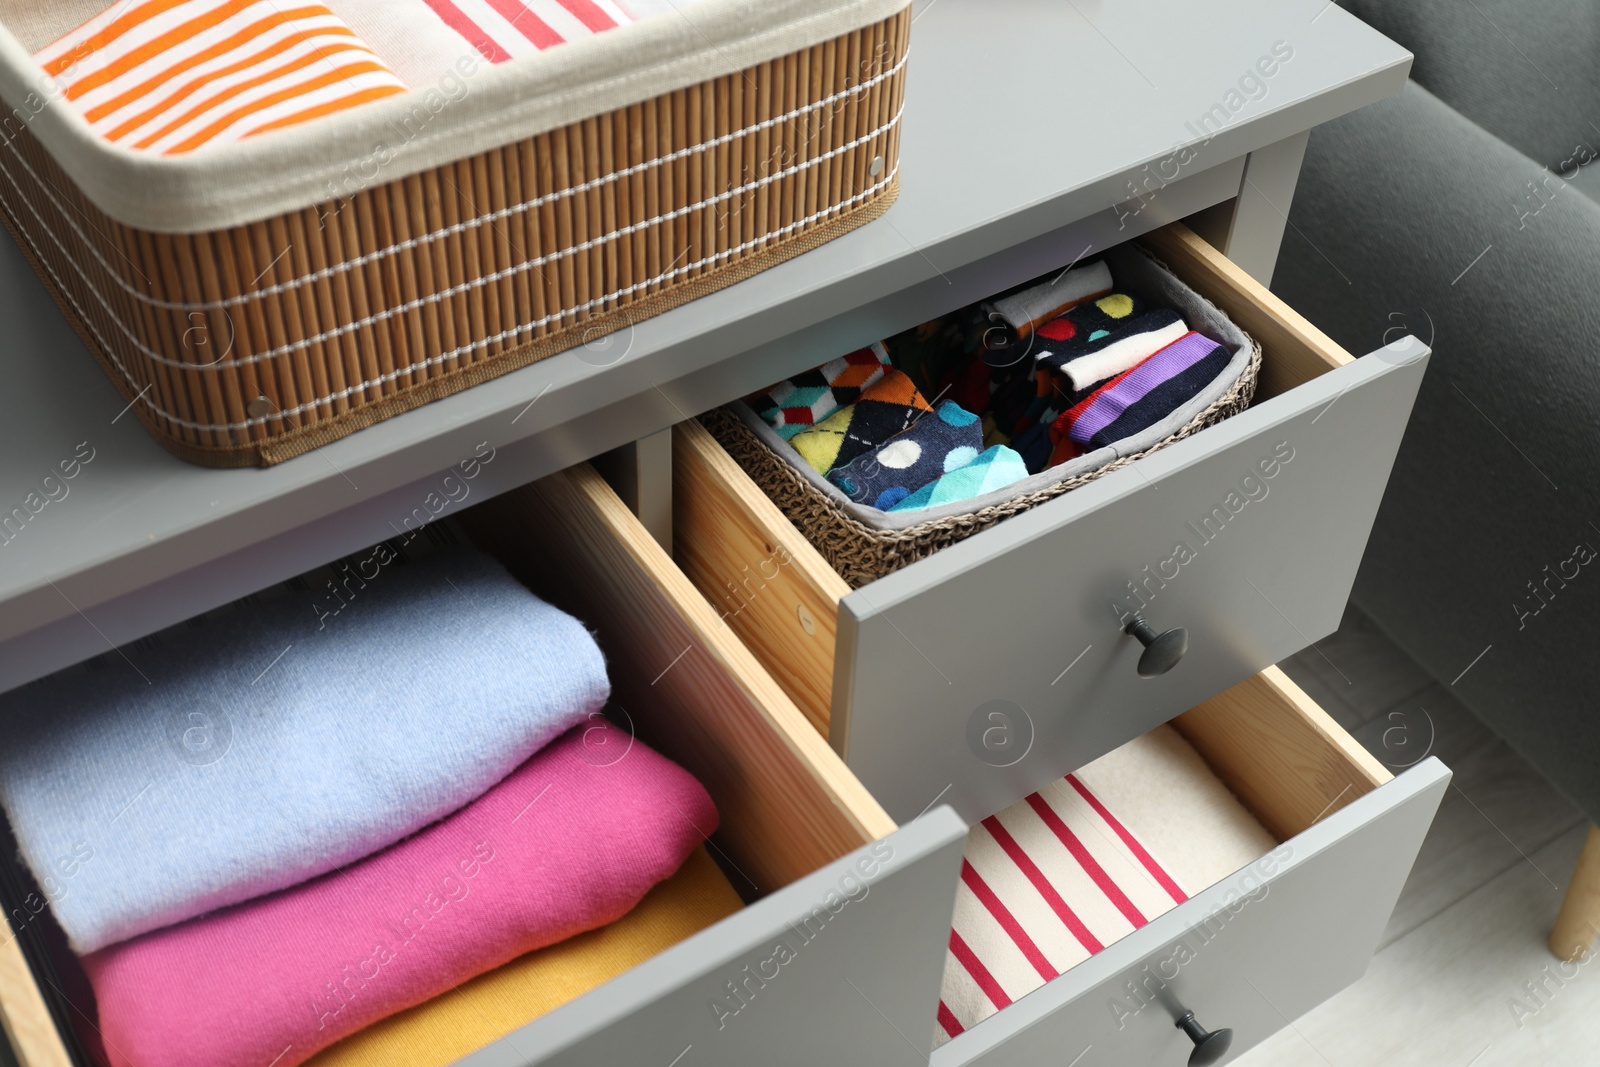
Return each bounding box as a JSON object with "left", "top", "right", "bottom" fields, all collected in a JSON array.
[{"left": 0, "top": 464, "right": 896, "bottom": 1067}]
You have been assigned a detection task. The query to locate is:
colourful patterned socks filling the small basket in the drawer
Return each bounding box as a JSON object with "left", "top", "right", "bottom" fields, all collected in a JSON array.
[{"left": 747, "top": 252, "right": 1235, "bottom": 514}]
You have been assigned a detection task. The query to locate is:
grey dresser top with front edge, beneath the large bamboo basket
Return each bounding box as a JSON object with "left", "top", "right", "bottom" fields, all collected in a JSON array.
[{"left": 0, "top": 0, "right": 1410, "bottom": 688}]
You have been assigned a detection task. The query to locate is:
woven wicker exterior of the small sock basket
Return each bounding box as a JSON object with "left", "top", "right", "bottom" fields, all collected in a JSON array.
[{"left": 701, "top": 338, "right": 1261, "bottom": 589}]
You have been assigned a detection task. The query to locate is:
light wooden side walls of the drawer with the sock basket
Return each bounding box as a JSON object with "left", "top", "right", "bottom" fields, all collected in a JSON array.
[{"left": 674, "top": 222, "right": 1352, "bottom": 736}]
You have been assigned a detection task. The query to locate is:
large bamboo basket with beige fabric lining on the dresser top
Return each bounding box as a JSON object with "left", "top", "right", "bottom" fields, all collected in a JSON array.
[{"left": 0, "top": 0, "right": 910, "bottom": 467}]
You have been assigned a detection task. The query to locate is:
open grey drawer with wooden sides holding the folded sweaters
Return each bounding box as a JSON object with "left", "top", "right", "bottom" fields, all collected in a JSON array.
[{"left": 0, "top": 466, "right": 966, "bottom": 1067}]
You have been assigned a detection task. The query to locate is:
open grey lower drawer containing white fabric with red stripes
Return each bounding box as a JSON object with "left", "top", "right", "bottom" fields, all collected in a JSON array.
[{"left": 931, "top": 667, "right": 1450, "bottom": 1067}]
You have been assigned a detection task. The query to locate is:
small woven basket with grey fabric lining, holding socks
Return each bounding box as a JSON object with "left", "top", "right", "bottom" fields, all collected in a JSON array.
[{"left": 699, "top": 250, "right": 1261, "bottom": 589}]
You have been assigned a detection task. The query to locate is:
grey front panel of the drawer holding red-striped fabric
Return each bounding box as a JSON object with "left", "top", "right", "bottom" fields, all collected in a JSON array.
[{"left": 931, "top": 760, "right": 1450, "bottom": 1067}]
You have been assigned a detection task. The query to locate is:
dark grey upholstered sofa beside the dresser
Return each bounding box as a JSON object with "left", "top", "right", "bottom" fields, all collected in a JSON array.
[{"left": 1272, "top": 0, "right": 1600, "bottom": 957}]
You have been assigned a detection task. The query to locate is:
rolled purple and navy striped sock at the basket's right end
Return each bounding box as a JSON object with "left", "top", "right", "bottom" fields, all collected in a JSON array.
[{"left": 1067, "top": 333, "right": 1230, "bottom": 448}]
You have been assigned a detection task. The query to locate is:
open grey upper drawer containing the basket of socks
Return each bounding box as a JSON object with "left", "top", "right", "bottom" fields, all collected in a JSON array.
[{"left": 674, "top": 224, "right": 1429, "bottom": 821}]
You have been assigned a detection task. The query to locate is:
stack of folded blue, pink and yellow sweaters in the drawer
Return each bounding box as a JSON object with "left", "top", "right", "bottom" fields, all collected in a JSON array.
[{"left": 0, "top": 547, "right": 739, "bottom": 1067}]
